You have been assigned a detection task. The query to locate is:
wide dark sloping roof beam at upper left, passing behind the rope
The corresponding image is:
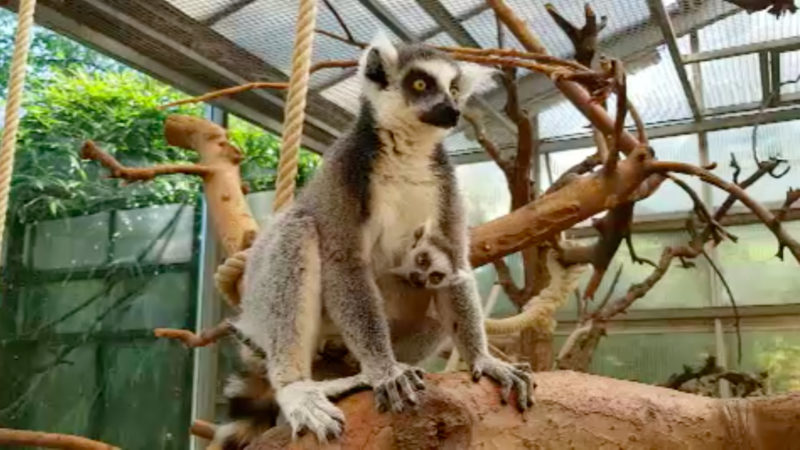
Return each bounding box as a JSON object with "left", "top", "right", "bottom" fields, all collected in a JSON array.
[{"left": 17, "top": 0, "right": 351, "bottom": 151}]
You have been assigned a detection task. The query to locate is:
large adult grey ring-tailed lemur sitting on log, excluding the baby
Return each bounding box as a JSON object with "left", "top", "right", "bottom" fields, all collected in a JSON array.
[{"left": 216, "top": 35, "right": 532, "bottom": 446}]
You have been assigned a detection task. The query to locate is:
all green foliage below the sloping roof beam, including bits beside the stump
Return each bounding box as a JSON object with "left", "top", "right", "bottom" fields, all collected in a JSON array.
[{"left": 0, "top": 6, "right": 319, "bottom": 222}]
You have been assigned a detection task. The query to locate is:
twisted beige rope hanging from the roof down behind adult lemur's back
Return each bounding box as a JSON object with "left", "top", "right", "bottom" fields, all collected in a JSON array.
[{"left": 272, "top": 0, "right": 317, "bottom": 212}]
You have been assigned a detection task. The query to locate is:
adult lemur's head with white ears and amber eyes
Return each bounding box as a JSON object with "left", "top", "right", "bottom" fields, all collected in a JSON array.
[{"left": 360, "top": 35, "right": 495, "bottom": 130}]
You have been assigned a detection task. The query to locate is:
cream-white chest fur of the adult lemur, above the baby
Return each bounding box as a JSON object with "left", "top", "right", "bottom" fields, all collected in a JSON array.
[{"left": 364, "top": 128, "right": 441, "bottom": 275}]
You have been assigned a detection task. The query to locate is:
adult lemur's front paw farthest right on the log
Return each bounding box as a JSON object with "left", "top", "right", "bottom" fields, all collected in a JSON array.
[{"left": 471, "top": 355, "right": 536, "bottom": 411}]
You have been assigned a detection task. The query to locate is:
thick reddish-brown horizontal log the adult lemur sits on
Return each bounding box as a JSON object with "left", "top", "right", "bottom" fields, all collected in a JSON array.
[{"left": 250, "top": 371, "right": 800, "bottom": 450}]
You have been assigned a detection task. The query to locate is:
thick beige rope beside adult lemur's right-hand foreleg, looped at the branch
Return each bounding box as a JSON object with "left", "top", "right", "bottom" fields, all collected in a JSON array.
[{"left": 484, "top": 250, "right": 586, "bottom": 334}]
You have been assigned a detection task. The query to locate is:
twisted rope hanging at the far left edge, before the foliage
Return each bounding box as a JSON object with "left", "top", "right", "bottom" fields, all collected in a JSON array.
[{"left": 0, "top": 0, "right": 36, "bottom": 253}]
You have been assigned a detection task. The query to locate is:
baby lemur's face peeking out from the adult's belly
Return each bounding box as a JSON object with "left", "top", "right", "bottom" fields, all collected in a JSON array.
[{"left": 392, "top": 224, "right": 468, "bottom": 289}]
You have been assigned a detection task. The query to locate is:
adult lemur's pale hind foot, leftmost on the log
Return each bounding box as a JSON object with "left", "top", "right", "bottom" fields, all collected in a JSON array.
[{"left": 275, "top": 381, "right": 344, "bottom": 443}]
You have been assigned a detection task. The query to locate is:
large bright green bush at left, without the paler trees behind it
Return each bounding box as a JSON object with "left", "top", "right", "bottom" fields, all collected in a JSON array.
[{"left": 12, "top": 71, "right": 202, "bottom": 222}]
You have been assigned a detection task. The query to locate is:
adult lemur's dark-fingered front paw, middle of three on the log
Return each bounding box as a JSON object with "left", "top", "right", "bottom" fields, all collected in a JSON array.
[{"left": 372, "top": 363, "right": 425, "bottom": 412}]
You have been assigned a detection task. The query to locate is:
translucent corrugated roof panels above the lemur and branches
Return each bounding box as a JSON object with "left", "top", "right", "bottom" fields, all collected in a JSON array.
[{"left": 34, "top": 0, "right": 800, "bottom": 151}]
